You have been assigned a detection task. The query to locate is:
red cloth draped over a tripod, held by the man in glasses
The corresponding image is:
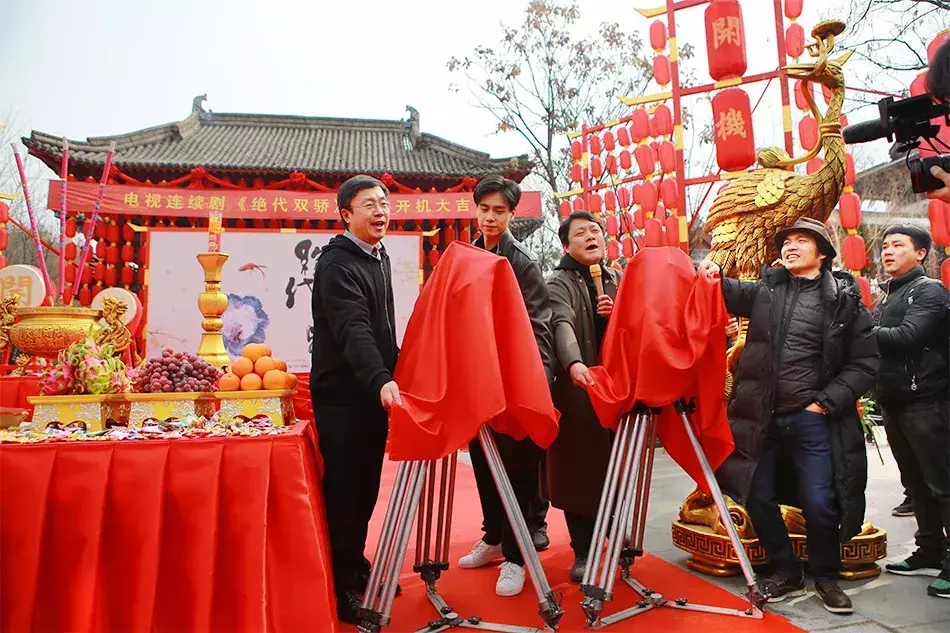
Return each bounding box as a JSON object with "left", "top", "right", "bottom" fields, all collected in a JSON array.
[{"left": 389, "top": 242, "right": 558, "bottom": 460}]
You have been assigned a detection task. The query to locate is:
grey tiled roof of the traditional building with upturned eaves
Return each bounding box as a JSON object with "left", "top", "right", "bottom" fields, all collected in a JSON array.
[{"left": 23, "top": 97, "right": 531, "bottom": 181}]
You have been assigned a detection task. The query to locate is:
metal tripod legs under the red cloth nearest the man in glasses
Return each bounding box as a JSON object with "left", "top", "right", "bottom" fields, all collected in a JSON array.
[{"left": 359, "top": 425, "right": 564, "bottom": 633}]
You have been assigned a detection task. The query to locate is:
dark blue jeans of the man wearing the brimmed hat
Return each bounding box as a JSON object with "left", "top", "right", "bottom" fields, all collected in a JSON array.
[{"left": 746, "top": 411, "right": 841, "bottom": 580}]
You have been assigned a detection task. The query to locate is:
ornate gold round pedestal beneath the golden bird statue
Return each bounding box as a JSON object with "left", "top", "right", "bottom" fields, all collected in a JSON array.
[{"left": 672, "top": 491, "right": 887, "bottom": 580}]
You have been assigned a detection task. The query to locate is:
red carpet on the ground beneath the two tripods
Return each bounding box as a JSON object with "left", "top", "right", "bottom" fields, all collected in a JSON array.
[{"left": 340, "top": 462, "right": 802, "bottom": 633}]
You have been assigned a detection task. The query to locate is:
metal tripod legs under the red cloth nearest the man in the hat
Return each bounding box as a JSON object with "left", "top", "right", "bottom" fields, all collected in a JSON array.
[{"left": 581, "top": 400, "right": 768, "bottom": 629}]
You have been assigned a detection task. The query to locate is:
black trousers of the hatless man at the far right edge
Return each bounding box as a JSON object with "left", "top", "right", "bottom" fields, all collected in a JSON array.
[{"left": 881, "top": 400, "right": 950, "bottom": 561}]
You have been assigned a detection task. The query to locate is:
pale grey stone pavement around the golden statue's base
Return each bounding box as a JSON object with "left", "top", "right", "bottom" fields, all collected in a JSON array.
[{"left": 648, "top": 446, "right": 950, "bottom": 633}]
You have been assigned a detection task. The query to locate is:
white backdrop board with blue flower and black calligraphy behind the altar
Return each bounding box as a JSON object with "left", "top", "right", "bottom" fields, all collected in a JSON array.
[{"left": 145, "top": 229, "right": 422, "bottom": 372}]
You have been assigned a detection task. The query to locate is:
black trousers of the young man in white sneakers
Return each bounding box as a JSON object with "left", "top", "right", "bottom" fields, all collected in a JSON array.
[{"left": 468, "top": 431, "right": 542, "bottom": 565}]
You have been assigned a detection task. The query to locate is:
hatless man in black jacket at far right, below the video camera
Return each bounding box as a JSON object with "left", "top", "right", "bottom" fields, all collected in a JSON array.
[{"left": 874, "top": 226, "right": 950, "bottom": 598}]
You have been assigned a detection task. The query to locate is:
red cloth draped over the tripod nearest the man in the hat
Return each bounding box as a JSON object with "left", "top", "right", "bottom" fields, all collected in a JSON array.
[{"left": 588, "top": 246, "right": 734, "bottom": 489}]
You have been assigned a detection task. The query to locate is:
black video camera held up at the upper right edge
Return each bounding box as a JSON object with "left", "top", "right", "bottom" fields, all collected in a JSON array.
[{"left": 842, "top": 93, "right": 950, "bottom": 193}]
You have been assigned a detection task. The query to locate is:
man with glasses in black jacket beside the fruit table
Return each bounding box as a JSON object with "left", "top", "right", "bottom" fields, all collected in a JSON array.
[{"left": 310, "top": 176, "right": 401, "bottom": 624}]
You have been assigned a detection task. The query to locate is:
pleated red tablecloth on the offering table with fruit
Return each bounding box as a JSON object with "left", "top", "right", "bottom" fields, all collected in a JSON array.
[{"left": 0, "top": 422, "right": 337, "bottom": 632}]
